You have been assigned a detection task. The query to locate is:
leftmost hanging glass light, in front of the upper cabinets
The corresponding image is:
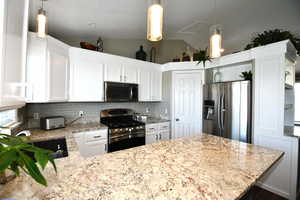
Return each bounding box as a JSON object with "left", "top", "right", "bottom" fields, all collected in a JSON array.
[{"left": 36, "top": 0, "right": 48, "bottom": 38}]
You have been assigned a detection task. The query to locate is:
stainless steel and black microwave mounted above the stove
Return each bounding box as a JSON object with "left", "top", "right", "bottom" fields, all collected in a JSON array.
[{"left": 104, "top": 82, "right": 139, "bottom": 102}]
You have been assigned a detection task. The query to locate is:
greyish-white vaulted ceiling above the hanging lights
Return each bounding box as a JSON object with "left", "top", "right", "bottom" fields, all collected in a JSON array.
[{"left": 30, "top": 0, "right": 300, "bottom": 51}]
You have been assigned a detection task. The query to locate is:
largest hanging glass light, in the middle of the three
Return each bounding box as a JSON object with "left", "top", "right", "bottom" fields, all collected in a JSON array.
[{"left": 147, "top": 0, "right": 163, "bottom": 41}]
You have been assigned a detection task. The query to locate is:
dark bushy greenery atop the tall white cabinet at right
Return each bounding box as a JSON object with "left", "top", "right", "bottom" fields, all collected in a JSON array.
[{"left": 245, "top": 29, "right": 300, "bottom": 55}]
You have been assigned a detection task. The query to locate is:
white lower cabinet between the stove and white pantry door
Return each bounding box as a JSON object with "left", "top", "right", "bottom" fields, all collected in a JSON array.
[{"left": 146, "top": 122, "right": 170, "bottom": 144}]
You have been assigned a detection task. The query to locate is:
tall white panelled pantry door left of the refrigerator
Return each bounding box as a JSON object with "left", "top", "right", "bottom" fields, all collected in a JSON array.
[{"left": 172, "top": 72, "right": 202, "bottom": 138}]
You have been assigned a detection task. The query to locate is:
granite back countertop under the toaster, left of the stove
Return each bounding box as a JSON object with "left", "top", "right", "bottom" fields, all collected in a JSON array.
[{"left": 29, "top": 123, "right": 107, "bottom": 141}]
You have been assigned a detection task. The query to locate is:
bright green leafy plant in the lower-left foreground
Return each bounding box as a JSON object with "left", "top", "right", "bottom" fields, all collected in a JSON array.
[{"left": 0, "top": 134, "right": 56, "bottom": 186}]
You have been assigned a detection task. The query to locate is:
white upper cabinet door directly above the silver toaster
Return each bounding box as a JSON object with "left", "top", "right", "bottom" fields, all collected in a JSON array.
[{"left": 47, "top": 50, "right": 69, "bottom": 101}]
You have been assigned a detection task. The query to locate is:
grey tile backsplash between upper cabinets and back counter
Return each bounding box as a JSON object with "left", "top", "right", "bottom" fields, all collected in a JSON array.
[{"left": 26, "top": 102, "right": 162, "bottom": 128}]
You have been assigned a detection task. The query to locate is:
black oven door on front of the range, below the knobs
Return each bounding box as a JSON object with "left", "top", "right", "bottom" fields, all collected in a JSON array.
[{"left": 108, "top": 131, "right": 145, "bottom": 152}]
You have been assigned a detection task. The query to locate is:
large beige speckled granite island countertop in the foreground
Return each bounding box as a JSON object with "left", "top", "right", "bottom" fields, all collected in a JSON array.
[{"left": 0, "top": 134, "right": 283, "bottom": 200}]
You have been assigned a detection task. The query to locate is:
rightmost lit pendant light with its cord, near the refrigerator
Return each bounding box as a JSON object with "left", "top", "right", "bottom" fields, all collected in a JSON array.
[{"left": 210, "top": 0, "right": 224, "bottom": 58}]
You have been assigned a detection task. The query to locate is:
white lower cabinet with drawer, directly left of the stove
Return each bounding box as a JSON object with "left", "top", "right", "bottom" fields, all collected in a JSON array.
[{"left": 74, "top": 129, "right": 108, "bottom": 157}]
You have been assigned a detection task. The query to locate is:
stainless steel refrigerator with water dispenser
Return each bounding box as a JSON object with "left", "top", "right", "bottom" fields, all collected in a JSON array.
[{"left": 203, "top": 81, "right": 252, "bottom": 143}]
